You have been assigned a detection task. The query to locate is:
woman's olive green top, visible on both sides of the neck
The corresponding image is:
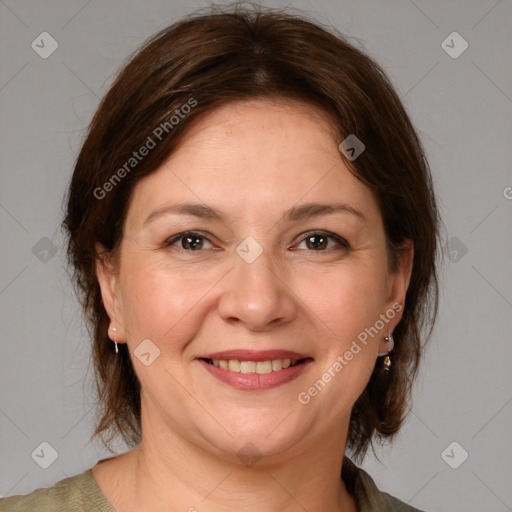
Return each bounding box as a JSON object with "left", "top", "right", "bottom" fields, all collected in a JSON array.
[{"left": 0, "top": 457, "right": 421, "bottom": 512}]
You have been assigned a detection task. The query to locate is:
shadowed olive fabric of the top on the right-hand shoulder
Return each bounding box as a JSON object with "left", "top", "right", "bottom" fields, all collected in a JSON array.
[{"left": 342, "top": 457, "right": 423, "bottom": 512}]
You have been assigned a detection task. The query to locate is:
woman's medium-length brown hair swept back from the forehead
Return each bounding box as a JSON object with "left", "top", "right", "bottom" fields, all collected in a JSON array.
[{"left": 63, "top": 5, "right": 440, "bottom": 457}]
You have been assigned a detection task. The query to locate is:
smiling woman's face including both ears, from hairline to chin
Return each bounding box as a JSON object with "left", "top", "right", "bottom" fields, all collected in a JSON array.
[{"left": 99, "top": 100, "right": 412, "bottom": 457}]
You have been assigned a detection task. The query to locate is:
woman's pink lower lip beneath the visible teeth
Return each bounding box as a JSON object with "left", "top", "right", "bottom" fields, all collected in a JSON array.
[{"left": 198, "top": 359, "right": 313, "bottom": 391}]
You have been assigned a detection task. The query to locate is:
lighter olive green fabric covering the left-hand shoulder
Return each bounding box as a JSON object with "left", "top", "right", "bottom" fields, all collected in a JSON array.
[{"left": 0, "top": 469, "right": 115, "bottom": 512}]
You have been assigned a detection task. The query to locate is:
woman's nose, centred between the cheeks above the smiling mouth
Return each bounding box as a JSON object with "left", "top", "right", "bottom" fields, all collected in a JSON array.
[{"left": 218, "top": 245, "right": 297, "bottom": 331}]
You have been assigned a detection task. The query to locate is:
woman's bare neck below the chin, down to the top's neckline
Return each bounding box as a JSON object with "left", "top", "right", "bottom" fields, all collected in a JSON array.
[{"left": 121, "top": 402, "right": 356, "bottom": 512}]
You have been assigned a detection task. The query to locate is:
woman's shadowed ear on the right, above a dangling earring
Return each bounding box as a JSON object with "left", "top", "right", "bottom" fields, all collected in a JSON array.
[{"left": 381, "top": 239, "right": 414, "bottom": 340}]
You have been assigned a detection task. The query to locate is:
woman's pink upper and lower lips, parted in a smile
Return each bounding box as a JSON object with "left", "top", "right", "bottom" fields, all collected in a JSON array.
[{"left": 198, "top": 350, "right": 313, "bottom": 391}]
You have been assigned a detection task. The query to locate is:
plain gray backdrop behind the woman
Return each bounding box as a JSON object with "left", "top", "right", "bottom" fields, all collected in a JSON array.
[{"left": 0, "top": 0, "right": 512, "bottom": 512}]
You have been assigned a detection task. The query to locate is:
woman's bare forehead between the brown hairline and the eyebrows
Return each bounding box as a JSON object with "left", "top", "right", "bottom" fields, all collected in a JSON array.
[{"left": 124, "top": 99, "right": 377, "bottom": 228}]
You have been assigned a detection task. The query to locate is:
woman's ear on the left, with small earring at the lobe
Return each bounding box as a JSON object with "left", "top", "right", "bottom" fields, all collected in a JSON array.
[{"left": 95, "top": 243, "right": 126, "bottom": 343}]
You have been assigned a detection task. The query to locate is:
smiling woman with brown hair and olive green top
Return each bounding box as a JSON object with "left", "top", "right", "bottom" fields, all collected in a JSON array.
[{"left": 0, "top": 4, "right": 439, "bottom": 512}]
